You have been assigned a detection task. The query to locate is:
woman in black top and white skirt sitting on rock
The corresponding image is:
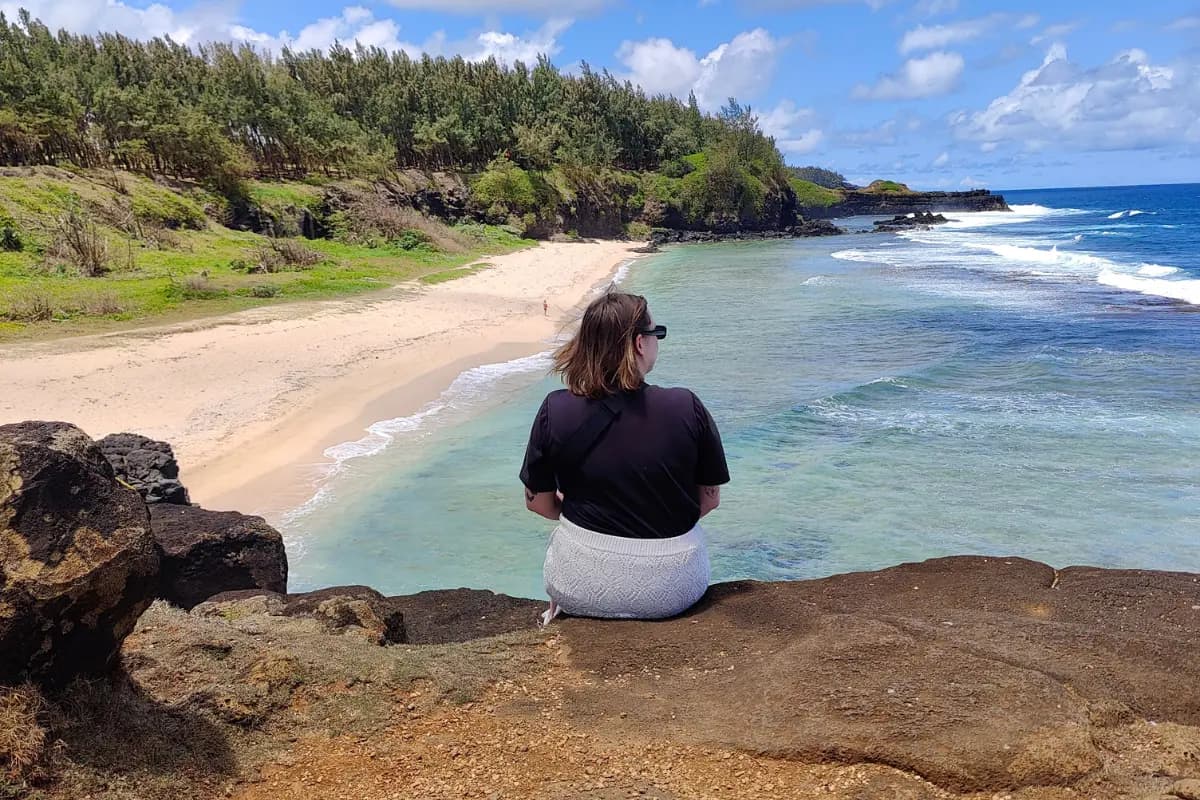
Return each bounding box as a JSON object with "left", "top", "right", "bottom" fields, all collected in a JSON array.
[{"left": 521, "top": 291, "right": 730, "bottom": 622}]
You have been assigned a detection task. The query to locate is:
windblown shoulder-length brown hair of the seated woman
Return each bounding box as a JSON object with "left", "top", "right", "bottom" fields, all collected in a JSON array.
[{"left": 554, "top": 291, "right": 650, "bottom": 398}]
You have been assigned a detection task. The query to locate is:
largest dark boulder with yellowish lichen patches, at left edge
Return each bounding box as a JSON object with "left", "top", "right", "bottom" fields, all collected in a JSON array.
[{"left": 0, "top": 422, "right": 158, "bottom": 687}]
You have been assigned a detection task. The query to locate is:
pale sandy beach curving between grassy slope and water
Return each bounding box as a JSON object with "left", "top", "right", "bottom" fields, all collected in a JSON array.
[{"left": 0, "top": 237, "right": 636, "bottom": 517}]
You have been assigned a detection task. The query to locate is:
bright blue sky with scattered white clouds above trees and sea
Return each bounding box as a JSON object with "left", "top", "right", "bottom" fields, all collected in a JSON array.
[{"left": 0, "top": 0, "right": 1200, "bottom": 190}]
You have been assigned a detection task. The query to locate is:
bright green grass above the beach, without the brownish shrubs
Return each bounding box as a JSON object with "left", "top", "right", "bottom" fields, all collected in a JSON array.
[{"left": 0, "top": 169, "right": 533, "bottom": 342}]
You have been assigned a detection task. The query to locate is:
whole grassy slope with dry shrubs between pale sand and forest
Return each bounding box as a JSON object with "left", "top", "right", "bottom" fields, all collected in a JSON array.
[{"left": 0, "top": 168, "right": 530, "bottom": 339}]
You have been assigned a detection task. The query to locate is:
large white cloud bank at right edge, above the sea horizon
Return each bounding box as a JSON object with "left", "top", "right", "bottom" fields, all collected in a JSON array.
[{"left": 949, "top": 44, "right": 1200, "bottom": 151}]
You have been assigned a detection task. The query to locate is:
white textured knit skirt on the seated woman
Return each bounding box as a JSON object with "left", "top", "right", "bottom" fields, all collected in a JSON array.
[{"left": 542, "top": 517, "right": 708, "bottom": 621}]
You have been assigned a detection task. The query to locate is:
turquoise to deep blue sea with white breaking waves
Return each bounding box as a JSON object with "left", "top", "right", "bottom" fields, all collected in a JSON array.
[{"left": 284, "top": 186, "right": 1200, "bottom": 597}]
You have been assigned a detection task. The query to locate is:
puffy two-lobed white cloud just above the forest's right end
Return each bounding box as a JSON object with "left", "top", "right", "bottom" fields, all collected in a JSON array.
[{"left": 617, "top": 28, "right": 782, "bottom": 109}]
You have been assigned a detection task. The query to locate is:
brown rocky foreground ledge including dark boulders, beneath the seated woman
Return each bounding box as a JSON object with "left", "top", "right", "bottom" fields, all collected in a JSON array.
[{"left": 0, "top": 422, "right": 1200, "bottom": 800}]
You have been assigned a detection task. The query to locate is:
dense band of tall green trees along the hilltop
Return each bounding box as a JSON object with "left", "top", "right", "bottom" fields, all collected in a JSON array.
[{"left": 0, "top": 11, "right": 782, "bottom": 180}]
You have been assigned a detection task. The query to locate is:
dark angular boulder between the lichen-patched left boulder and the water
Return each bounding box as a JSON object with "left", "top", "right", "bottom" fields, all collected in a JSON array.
[{"left": 150, "top": 504, "right": 288, "bottom": 608}]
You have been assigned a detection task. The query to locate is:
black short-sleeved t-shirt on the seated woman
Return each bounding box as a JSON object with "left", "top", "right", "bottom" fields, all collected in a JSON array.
[{"left": 521, "top": 384, "right": 730, "bottom": 539}]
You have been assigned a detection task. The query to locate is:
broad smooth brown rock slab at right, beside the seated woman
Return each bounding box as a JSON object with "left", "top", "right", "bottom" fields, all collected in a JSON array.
[{"left": 560, "top": 557, "right": 1200, "bottom": 792}]
